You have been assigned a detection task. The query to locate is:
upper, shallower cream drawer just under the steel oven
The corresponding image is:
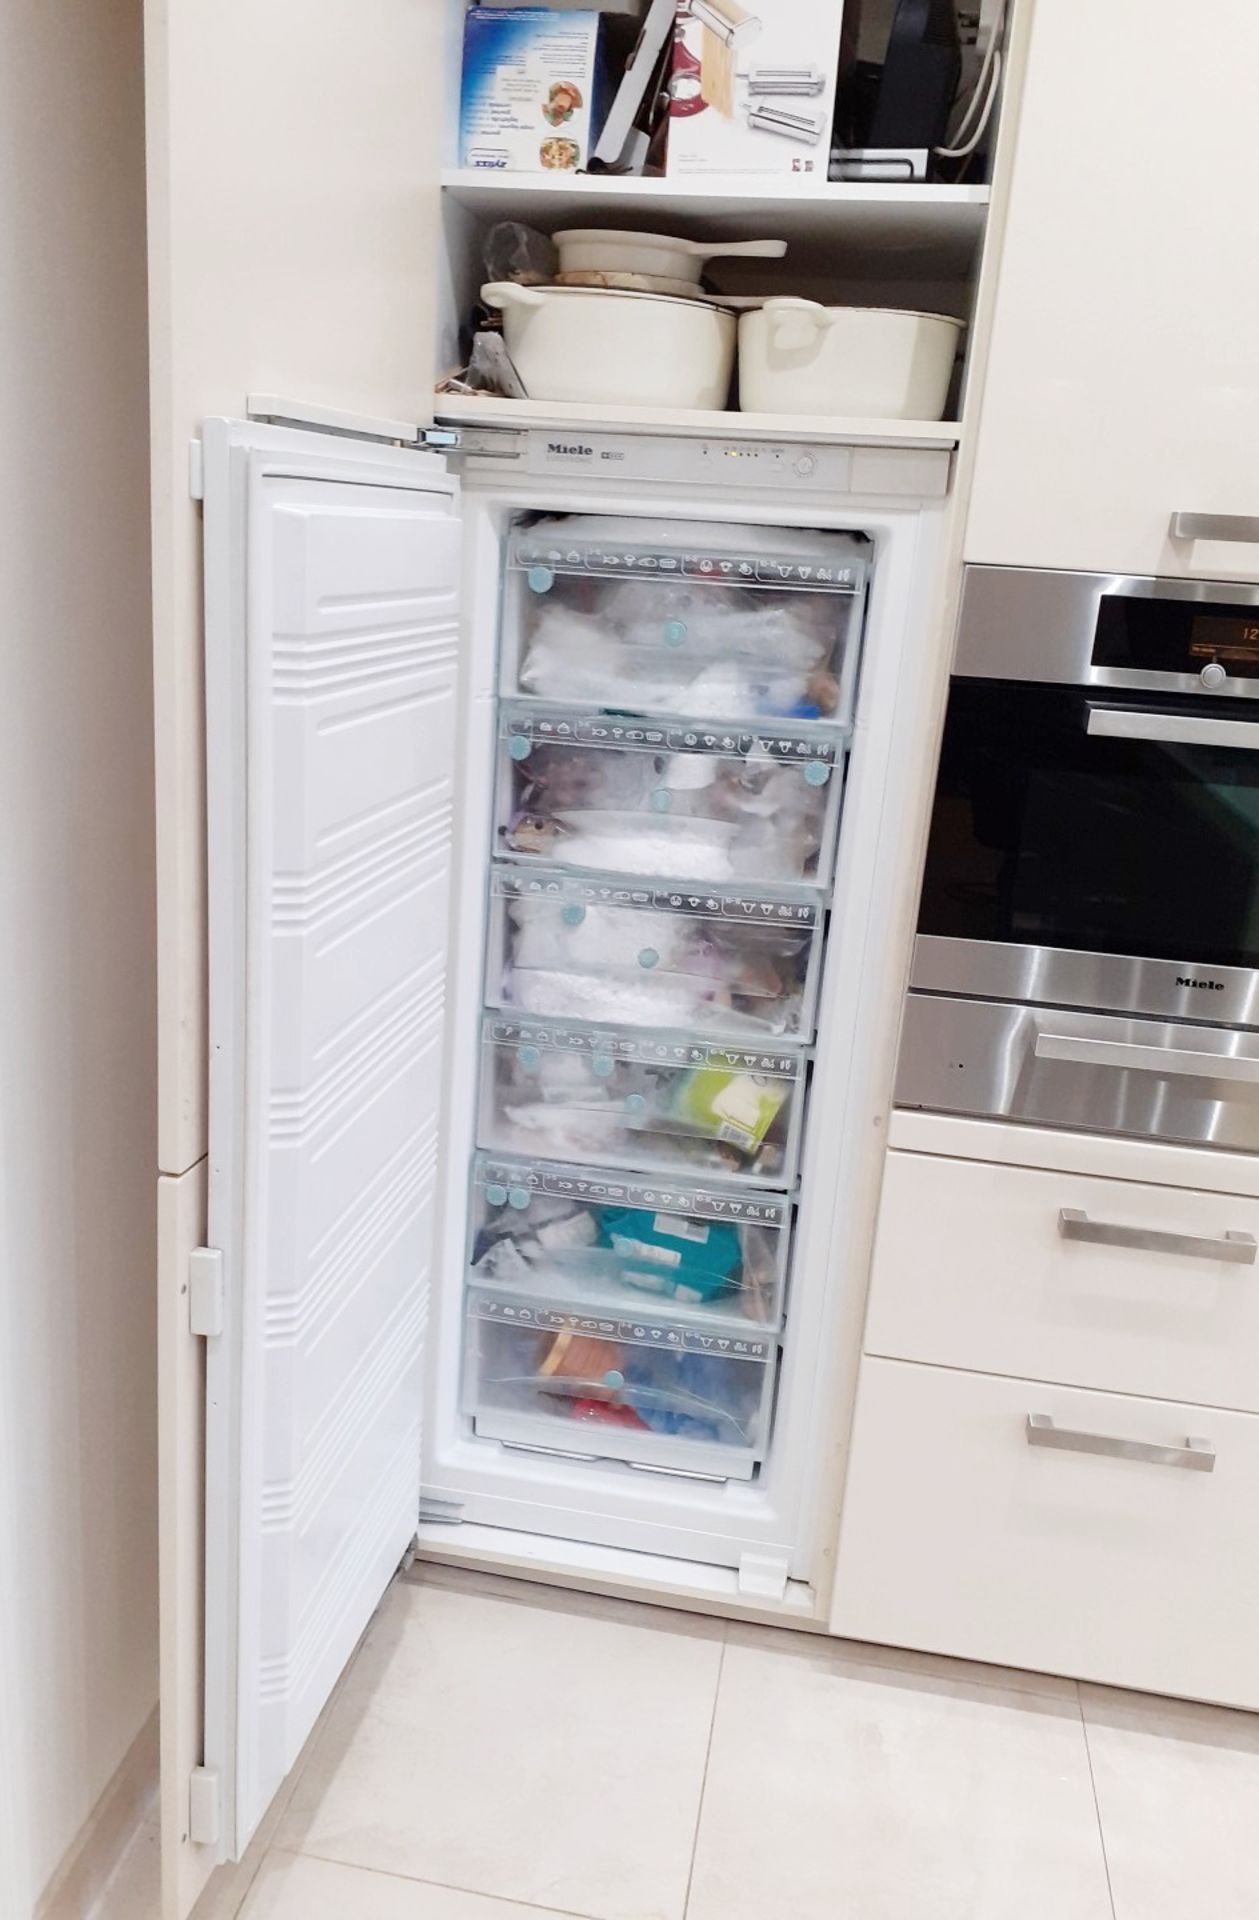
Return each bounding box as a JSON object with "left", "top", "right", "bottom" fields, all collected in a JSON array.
[{"left": 866, "top": 1152, "right": 1259, "bottom": 1411}]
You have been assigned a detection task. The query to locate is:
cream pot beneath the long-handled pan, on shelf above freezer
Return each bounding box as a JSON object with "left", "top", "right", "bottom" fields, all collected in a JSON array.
[{"left": 482, "top": 280, "right": 737, "bottom": 407}]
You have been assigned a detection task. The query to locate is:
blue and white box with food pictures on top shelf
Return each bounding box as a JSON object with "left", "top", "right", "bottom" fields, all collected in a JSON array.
[{"left": 459, "top": 6, "right": 606, "bottom": 173}]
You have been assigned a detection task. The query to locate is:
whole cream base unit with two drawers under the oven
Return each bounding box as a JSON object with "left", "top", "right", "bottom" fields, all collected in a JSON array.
[{"left": 833, "top": 1112, "right": 1259, "bottom": 1709}]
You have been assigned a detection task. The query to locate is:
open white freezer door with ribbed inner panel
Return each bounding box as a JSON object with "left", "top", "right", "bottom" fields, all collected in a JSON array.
[{"left": 194, "top": 420, "right": 459, "bottom": 1859}]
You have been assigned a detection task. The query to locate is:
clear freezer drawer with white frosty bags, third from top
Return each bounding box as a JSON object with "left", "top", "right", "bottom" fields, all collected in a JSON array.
[{"left": 486, "top": 866, "right": 823, "bottom": 1039}]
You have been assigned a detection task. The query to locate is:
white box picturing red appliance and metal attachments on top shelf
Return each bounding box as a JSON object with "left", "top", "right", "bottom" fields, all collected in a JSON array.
[{"left": 666, "top": 0, "right": 843, "bottom": 180}]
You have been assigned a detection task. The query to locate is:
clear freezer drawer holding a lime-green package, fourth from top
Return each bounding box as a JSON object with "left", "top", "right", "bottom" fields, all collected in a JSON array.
[{"left": 476, "top": 1014, "right": 806, "bottom": 1190}]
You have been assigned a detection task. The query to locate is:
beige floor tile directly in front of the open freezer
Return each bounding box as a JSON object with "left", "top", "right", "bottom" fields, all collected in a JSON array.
[{"left": 276, "top": 1582, "right": 724, "bottom": 1920}]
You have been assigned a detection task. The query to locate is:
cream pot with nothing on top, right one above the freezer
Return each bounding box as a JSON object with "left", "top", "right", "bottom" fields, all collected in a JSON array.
[{"left": 739, "top": 300, "right": 965, "bottom": 420}]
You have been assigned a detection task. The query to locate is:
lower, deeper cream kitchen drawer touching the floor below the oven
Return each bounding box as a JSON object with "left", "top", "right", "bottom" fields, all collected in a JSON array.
[{"left": 831, "top": 1359, "right": 1259, "bottom": 1709}]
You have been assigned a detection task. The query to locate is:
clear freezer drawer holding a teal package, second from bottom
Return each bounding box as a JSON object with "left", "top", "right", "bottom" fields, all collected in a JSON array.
[{"left": 468, "top": 1154, "right": 791, "bottom": 1331}]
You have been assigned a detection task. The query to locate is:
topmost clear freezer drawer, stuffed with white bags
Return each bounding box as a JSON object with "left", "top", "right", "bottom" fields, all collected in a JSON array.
[{"left": 501, "top": 518, "right": 869, "bottom": 726}]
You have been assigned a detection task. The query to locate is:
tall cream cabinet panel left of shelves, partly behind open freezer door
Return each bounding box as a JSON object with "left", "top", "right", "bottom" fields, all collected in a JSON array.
[{"left": 144, "top": 0, "right": 449, "bottom": 1920}]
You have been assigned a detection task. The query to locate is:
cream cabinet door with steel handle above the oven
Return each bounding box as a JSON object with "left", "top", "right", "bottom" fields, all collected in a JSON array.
[{"left": 965, "top": 0, "right": 1259, "bottom": 580}]
